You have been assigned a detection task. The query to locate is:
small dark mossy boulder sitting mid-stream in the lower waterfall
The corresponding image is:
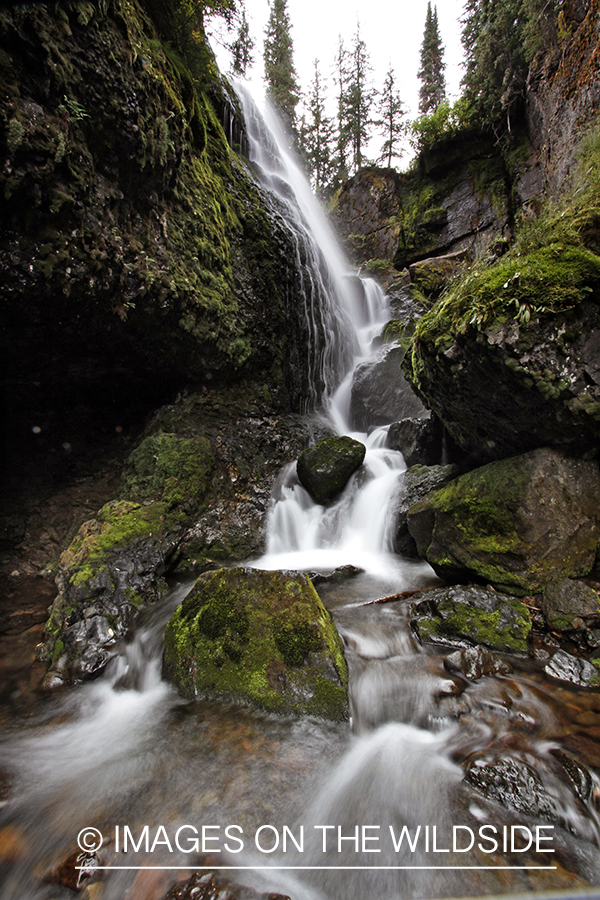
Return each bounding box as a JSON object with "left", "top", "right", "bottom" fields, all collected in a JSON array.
[{"left": 297, "top": 437, "right": 366, "bottom": 504}]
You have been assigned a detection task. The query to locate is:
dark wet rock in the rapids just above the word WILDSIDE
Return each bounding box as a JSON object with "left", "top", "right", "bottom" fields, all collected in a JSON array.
[{"left": 465, "top": 759, "right": 560, "bottom": 821}]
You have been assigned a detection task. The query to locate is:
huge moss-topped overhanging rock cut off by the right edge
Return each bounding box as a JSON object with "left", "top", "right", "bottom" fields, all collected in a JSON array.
[{"left": 403, "top": 243, "right": 600, "bottom": 461}]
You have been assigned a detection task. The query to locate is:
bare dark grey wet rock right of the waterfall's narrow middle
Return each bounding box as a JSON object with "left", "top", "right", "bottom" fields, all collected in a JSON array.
[{"left": 350, "top": 344, "right": 428, "bottom": 431}]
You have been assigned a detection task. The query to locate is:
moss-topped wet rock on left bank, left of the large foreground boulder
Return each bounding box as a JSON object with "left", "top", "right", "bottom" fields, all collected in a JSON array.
[{"left": 37, "top": 500, "right": 183, "bottom": 687}]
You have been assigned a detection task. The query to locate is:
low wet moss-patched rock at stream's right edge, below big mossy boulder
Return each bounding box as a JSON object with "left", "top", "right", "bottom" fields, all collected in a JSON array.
[{"left": 410, "top": 585, "right": 531, "bottom": 656}]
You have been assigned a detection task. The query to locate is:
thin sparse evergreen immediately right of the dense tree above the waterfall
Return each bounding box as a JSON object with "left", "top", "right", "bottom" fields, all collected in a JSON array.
[{"left": 301, "top": 59, "right": 335, "bottom": 195}]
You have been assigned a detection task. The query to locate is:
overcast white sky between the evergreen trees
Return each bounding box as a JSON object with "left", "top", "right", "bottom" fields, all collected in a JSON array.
[{"left": 212, "top": 0, "right": 464, "bottom": 118}]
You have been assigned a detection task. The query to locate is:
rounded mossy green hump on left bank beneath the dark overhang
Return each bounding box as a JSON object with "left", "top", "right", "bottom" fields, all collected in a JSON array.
[{"left": 123, "top": 433, "right": 215, "bottom": 509}]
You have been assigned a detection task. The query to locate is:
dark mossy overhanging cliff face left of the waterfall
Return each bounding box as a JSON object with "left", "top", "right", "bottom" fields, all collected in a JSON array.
[{"left": 0, "top": 0, "right": 314, "bottom": 478}]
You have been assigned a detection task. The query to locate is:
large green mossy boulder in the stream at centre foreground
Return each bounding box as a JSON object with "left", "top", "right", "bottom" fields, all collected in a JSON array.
[{"left": 163, "top": 568, "right": 348, "bottom": 721}]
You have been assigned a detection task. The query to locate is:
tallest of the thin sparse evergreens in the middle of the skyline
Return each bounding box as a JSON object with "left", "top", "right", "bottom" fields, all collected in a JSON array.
[{"left": 342, "top": 25, "right": 375, "bottom": 172}]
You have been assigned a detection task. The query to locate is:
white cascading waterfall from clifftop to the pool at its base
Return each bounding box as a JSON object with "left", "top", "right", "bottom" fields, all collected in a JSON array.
[{"left": 238, "top": 86, "right": 430, "bottom": 590}]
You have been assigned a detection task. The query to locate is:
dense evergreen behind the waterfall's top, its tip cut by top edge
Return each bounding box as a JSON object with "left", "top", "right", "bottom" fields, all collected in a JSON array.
[{"left": 264, "top": 0, "right": 300, "bottom": 133}]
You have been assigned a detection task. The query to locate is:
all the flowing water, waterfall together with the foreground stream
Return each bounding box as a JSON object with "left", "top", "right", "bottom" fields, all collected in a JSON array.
[{"left": 0, "top": 86, "right": 600, "bottom": 900}]
